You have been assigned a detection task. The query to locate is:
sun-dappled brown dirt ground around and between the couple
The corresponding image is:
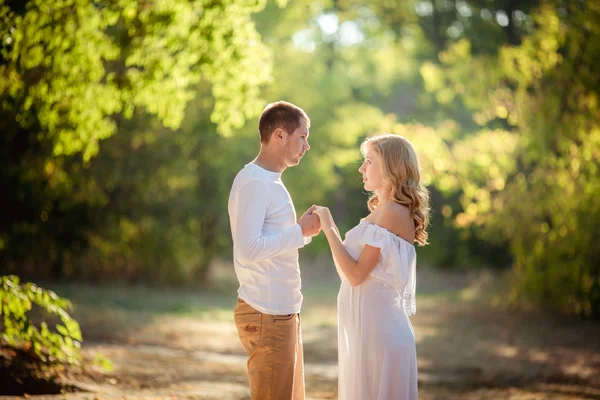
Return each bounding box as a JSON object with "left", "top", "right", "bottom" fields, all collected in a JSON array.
[{"left": 7, "top": 270, "right": 600, "bottom": 400}]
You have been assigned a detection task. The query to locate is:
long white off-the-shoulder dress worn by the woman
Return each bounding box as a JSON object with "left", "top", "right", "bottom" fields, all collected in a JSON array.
[{"left": 337, "top": 219, "right": 418, "bottom": 400}]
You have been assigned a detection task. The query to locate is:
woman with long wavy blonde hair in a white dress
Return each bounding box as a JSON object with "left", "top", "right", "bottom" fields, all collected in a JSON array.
[{"left": 313, "top": 134, "right": 429, "bottom": 400}]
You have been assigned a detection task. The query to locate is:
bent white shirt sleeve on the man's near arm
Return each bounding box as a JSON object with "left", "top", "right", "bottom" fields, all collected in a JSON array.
[{"left": 230, "top": 179, "right": 306, "bottom": 264}]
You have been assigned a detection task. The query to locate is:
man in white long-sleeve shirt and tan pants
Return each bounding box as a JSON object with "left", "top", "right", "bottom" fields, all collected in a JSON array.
[{"left": 229, "top": 101, "right": 321, "bottom": 400}]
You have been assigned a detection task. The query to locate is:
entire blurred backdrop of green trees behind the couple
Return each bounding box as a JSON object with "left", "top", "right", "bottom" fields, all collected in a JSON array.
[{"left": 0, "top": 0, "right": 600, "bottom": 318}]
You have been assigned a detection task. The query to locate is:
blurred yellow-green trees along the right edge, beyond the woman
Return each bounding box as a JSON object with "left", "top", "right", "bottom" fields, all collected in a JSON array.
[{"left": 416, "top": 1, "right": 600, "bottom": 318}]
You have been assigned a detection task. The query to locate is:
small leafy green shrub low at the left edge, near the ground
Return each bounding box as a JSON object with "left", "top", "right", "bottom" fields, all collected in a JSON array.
[{"left": 0, "top": 275, "right": 82, "bottom": 364}]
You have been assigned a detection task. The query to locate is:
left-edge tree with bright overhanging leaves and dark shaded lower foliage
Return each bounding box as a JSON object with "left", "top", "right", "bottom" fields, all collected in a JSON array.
[{"left": 0, "top": 0, "right": 271, "bottom": 277}]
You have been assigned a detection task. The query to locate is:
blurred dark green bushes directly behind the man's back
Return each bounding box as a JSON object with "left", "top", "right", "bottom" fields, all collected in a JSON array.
[{"left": 77, "top": 93, "right": 234, "bottom": 284}]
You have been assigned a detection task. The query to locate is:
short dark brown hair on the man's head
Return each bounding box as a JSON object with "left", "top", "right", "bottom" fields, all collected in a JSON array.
[{"left": 258, "top": 101, "right": 310, "bottom": 143}]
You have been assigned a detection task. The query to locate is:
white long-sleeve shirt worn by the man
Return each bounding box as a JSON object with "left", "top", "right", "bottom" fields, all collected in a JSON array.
[{"left": 228, "top": 163, "right": 310, "bottom": 315}]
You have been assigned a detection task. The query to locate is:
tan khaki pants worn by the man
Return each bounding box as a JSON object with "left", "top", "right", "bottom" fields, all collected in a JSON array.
[{"left": 234, "top": 298, "right": 304, "bottom": 400}]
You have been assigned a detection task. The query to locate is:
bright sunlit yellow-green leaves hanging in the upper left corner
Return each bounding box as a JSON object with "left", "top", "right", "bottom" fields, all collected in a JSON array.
[{"left": 0, "top": 0, "right": 270, "bottom": 161}]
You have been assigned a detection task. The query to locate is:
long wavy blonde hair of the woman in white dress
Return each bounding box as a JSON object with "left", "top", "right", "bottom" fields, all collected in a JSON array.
[{"left": 360, "top": 133, "right": 429, "bottom": 246}]
